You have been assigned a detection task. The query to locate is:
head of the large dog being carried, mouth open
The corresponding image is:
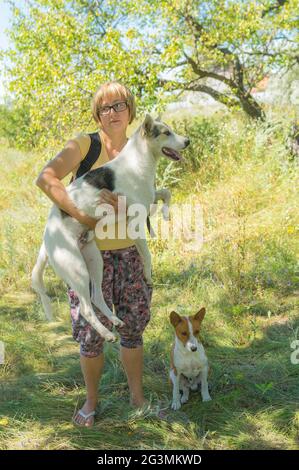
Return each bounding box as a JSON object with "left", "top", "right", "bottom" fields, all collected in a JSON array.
[{"left": 140, "top": 114, "right": 190, "bottom": 161}]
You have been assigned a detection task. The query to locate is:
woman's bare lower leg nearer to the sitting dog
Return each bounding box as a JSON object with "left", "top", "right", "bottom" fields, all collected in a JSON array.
[{"left": 120, "top": 346, "right": 146, "bottom": 407}]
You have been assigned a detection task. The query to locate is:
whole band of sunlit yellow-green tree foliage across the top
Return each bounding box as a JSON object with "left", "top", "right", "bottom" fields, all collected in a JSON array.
[{"left": 2, "top": 0, "right": 298, "bottom": 147}]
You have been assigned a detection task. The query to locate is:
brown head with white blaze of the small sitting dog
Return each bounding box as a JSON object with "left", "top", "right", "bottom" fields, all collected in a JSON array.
[{"left": 170, "top": 307, "right": 206, "bottom": 352}]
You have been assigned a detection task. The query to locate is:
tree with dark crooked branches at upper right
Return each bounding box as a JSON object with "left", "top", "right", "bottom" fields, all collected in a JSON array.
[{"left": 135, "top": 0, "right": 299, "bottom": 119}]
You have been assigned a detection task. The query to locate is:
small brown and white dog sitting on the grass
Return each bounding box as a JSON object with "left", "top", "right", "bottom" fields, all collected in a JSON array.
[{"left": 170, "top": 307, "right": 211, "bottom": 410}]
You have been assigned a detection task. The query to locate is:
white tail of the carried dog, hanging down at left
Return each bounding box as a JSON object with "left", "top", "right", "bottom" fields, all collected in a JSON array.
[{"left": 31, "top": 243, "right": 53, "bottom": 321}]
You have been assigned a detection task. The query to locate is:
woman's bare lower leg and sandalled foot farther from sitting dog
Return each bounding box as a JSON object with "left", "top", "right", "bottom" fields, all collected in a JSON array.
[{"left": 74, "top": 353, "right": 104, "bottom": 427}]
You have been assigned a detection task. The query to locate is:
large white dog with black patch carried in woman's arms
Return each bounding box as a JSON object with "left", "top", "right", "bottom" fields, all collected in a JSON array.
[{"left": 32, "top": 114, "right": 190, "bottom": 341}]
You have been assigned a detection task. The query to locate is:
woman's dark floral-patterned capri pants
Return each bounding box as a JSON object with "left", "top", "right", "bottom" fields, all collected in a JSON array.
[{"left": 68, "top": 246, "right": 152, "bottom": 357}]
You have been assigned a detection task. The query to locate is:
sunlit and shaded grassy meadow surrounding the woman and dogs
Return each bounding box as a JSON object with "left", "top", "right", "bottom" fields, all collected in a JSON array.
[{"left": 0, "top": 112, "right": 299, "bottom": 449}]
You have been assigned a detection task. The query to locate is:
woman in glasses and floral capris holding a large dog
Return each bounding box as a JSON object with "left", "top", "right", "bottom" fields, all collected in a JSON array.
[{"left": 37, "top": 82, "right": 152, "bottom": 426}]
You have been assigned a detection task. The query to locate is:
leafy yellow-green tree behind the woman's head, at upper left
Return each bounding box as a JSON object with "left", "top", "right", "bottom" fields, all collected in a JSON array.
[{"left": 2, "top": 0, "right": 161, "bottom": 146}]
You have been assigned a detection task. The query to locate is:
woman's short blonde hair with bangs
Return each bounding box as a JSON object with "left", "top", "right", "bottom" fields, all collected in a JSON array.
[{"left": 91, "top": 82, "right": 136, "bottom": 124}]
